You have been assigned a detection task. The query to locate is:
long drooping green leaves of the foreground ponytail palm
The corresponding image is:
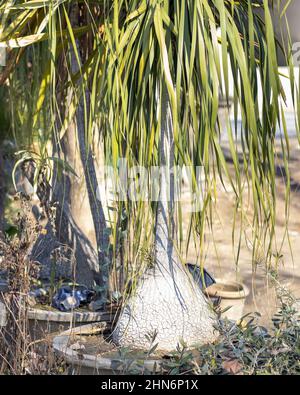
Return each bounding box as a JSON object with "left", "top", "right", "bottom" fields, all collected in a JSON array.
[{"left": 106, "top": 0, "right": 296, "bottom": 270}]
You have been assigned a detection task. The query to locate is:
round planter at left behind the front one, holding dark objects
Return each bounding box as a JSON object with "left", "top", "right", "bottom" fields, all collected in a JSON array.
[{"left": 28, "top": 308, "right": 115, "bottom": 340}]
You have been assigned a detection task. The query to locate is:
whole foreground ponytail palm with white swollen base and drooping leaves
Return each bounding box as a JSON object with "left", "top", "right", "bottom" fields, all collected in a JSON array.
[{"left": 107, "top": 0, "right": 292, "bottom": 350}]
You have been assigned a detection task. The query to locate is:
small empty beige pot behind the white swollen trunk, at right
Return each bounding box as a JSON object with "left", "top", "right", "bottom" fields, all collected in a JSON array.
[{"left": 205, "top": 279, "right": 249, "bottom": 321}]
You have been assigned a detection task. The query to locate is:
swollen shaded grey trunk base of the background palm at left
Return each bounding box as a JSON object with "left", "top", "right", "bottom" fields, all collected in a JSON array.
[{"left": 25, "top": 135, "right": 99, "bottom": 287}]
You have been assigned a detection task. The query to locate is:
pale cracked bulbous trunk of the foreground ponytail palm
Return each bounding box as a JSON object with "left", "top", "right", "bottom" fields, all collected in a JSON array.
[{"left": 113, "top": 89, "right": 217, "bottom": 352}]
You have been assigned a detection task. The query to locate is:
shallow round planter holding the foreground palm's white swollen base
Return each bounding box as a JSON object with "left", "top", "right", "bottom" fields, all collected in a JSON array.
[{"left": 52, "top": 323, "right": 162, "bottom": 375}]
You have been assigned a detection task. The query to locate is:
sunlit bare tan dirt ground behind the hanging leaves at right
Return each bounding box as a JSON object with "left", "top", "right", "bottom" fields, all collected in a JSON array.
[{"left": 185, "top": 140, "right": 300, "bottom": 327}]
